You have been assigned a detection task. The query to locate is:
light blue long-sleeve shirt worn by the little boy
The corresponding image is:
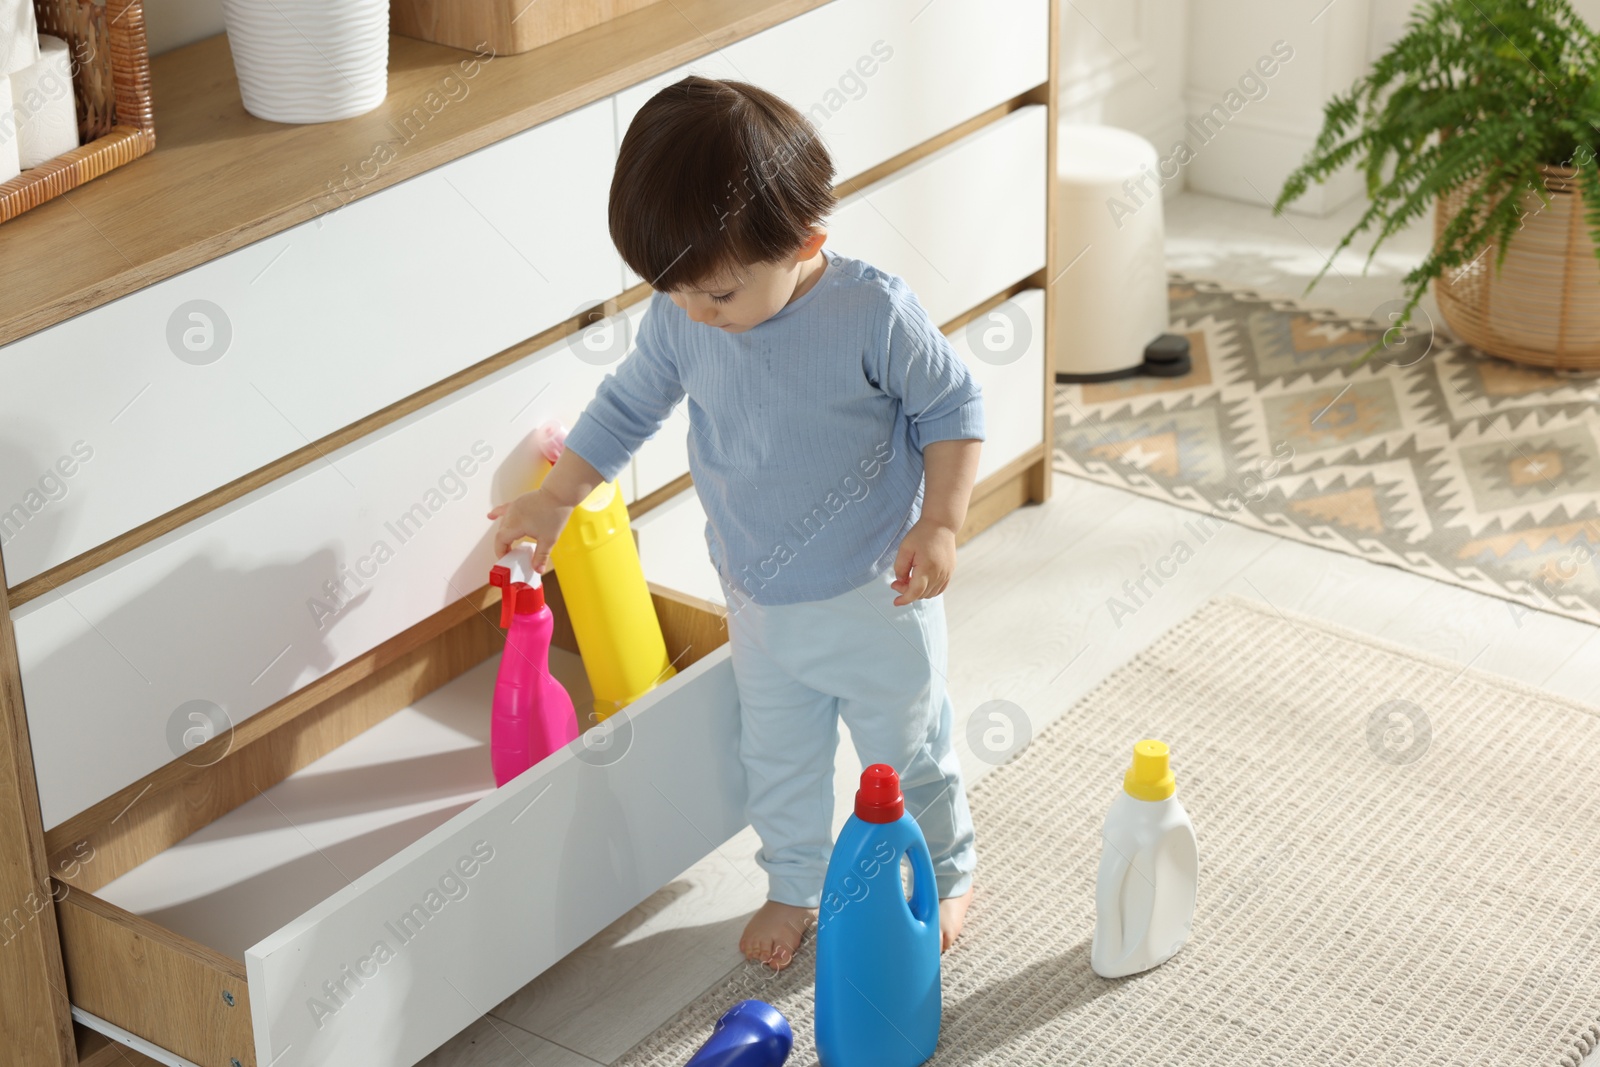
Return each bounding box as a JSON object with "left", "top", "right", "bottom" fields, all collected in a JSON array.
[{"left": 566, "top": 244, "right": 984, "bottom": 608}]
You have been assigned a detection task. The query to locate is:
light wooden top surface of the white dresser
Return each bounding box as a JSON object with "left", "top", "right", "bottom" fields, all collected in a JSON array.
[{"left": 0, "top": 0, "right": 826, "bottom": 344}]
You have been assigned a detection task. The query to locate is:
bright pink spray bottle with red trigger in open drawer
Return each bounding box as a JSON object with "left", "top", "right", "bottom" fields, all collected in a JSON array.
[{"left": 490, "top": 542, "right": 578, "bottom": 785}]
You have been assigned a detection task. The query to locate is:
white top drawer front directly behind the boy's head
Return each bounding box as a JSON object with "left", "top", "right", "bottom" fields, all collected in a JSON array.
[{"left": 616, "top": 0, "right": 1050, "bottom": 285}]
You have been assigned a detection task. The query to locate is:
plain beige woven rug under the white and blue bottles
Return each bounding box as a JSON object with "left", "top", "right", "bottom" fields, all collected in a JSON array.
[{"left": 618, "top": 598, "right": 1600, "bottom": 1067}]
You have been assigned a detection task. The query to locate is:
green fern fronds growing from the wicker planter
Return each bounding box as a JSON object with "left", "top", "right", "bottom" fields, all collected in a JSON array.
[{"left": 1272, "top": 0, "right": 1600, "bottom": 365}]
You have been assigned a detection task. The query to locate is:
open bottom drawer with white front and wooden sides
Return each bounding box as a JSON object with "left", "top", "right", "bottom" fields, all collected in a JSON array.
[{"left": 59, "top": 588, "right": 744, "bottom": 1067}]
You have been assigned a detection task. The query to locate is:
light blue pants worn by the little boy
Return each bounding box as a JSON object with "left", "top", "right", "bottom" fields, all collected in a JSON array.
[{"left": 728, "top": 573, "right": 978, "bottom": 907}]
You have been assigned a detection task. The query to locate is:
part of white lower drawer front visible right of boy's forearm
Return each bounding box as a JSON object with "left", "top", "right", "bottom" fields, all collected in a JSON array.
[{"left": 950, "top": 290, "right": 1045, "bottom": 482}]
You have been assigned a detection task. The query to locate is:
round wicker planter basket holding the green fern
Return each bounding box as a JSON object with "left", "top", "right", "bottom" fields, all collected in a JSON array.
[{"left": 1434, "top": 166, "right": 1600, "bottom": 373}]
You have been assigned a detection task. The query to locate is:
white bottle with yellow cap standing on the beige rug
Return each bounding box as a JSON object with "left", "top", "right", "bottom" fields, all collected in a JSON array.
[{"left": 1090, "top": 741, "right": 1198, "bottom": 977}]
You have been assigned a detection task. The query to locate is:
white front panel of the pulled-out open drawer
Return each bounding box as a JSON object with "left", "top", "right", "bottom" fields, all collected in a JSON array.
[{"left": 245, "top": 648, "right": 746, "bottom": 1067}]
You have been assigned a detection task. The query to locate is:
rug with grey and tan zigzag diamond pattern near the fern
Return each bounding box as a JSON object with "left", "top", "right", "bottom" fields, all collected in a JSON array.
[{"left": 1054, "top": 277, "right": 1600, "bottom": 624}]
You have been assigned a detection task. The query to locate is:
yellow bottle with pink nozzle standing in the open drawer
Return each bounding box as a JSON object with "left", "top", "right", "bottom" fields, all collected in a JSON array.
[{"left": 534, "top": 422, "right": 677, "bottom": 721}]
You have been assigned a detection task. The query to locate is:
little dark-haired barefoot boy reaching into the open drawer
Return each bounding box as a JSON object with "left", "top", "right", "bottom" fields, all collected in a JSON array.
[{"left": 490, "top": 77, "right": 984, "bottom": 969}]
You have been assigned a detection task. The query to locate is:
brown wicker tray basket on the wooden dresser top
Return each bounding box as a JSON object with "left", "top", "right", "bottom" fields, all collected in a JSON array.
[{"left": 0, "top": 0, "right": 155, "bottom": 222}]
